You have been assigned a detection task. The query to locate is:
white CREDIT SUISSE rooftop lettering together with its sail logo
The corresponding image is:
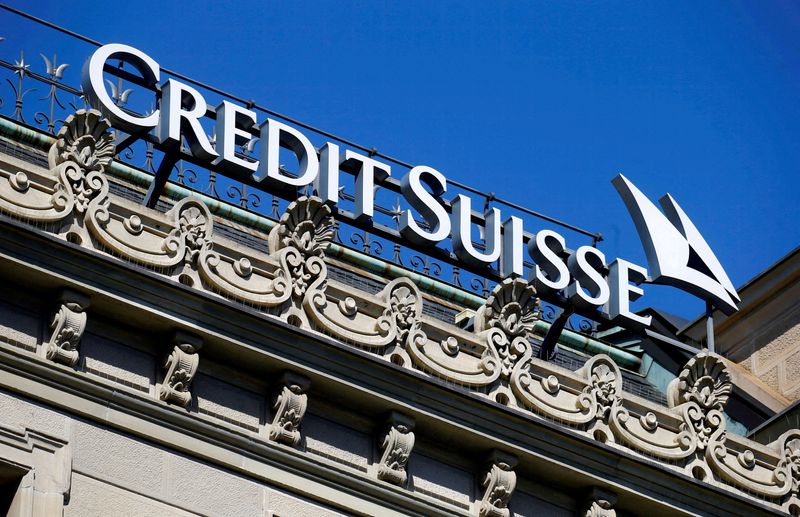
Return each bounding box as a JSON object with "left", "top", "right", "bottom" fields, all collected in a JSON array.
[{"left": 82, "top": 44, "right": 738, "bottom": 326}]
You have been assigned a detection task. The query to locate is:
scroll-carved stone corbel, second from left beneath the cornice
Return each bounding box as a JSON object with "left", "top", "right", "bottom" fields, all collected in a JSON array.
[{"left": 158, "top": 331, "right": 203, "bottom": 407}]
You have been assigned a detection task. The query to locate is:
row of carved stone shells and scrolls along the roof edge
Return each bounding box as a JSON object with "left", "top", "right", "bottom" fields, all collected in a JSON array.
[{"left": 0, "top": 110, "right": 800, "bottom": 506}]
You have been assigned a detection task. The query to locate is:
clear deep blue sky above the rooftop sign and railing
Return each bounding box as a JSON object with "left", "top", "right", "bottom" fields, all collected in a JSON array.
[{"left": 0, "top": 0, "right": 800, "bottom": 317}]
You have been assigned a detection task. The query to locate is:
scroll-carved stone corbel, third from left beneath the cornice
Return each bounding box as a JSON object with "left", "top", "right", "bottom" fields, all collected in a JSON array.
[{"left": 269, "top": 372, "right": 311, "bottom": 447}]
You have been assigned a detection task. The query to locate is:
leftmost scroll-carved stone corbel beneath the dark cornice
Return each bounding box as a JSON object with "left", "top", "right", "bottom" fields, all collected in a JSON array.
[{"left": 42, "top": 289, "right": 89, "bottom": 366}]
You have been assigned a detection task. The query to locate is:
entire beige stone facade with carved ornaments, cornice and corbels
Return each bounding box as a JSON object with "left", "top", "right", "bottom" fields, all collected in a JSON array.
[{"left": 0, "top": 110, "right": 800, "bottom": 517}]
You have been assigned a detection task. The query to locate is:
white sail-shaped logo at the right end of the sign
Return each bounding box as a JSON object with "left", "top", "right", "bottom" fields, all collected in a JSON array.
[{"left": 611, "top": 174, "right": 740, "bottom": 314}]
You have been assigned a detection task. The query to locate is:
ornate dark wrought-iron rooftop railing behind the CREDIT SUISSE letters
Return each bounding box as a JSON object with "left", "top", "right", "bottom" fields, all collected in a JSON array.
[{"left": 0, "top": 4, "right": 602, "bottom": 333}]
